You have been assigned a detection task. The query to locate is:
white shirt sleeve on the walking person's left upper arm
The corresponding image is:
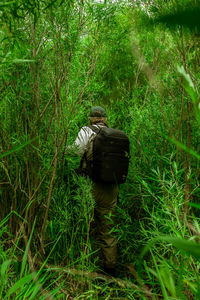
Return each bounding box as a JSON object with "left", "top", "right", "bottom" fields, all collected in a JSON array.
[{"left": 74, "top": 126, "right": 96, "bottom": 156}]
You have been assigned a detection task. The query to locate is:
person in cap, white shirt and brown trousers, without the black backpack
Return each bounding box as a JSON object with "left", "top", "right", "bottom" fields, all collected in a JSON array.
[{"left": 74, "top": 106, "right": 121, "bottom": 275}]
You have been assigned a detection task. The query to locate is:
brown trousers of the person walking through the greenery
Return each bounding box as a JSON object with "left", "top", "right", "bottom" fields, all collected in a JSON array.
[{"left": 92, "top": 182, "right": 118, "bottom": 268}]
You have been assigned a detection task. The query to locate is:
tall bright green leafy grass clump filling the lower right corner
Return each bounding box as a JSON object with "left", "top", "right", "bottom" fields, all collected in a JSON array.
[{"left": 139, "top": 161, "right": 200, "bottom": 299}]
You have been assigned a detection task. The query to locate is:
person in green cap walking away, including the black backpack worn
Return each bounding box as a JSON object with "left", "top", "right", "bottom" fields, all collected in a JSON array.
[{"left": 71, "top": 106, "right": 129, "bottom": 275}]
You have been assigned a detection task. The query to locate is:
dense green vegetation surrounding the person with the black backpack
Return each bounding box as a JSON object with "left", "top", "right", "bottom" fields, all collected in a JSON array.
[{"left": 0, "top": 0, "right": 200, "bottom": 299}]
